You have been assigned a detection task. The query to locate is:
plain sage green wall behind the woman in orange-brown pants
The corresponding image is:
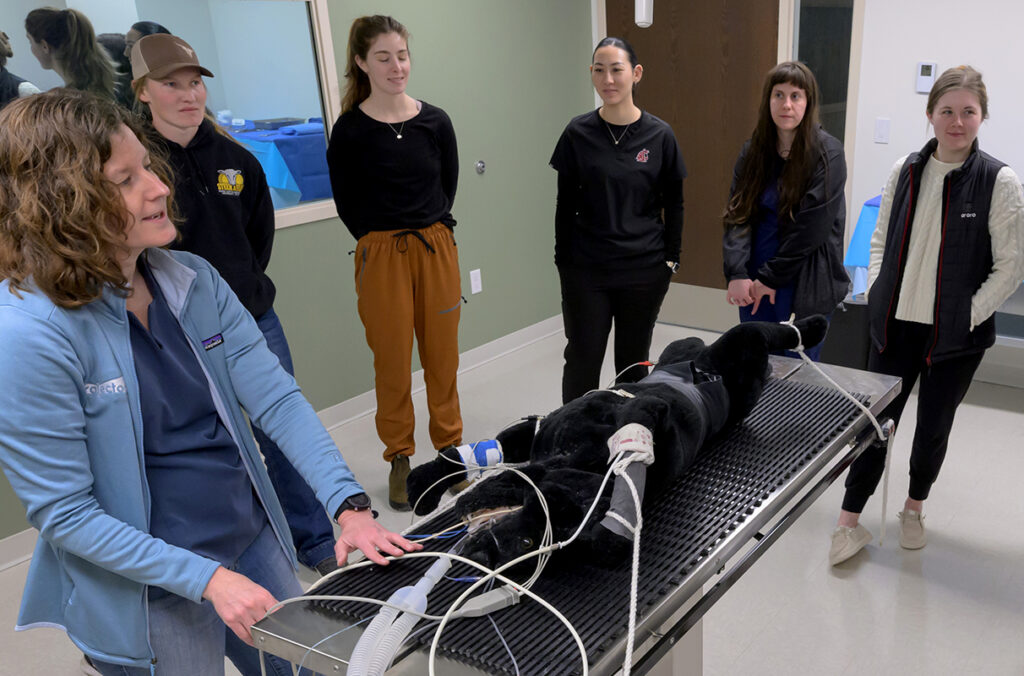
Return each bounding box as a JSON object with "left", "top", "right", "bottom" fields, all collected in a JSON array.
[{"left": 0, "top": 0, "right": 593, "bottom": 538}]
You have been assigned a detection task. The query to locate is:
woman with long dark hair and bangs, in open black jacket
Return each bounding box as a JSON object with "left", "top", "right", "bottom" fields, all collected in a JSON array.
[{"left": 722, "top": 61, "right": 850, "bottom": 360}]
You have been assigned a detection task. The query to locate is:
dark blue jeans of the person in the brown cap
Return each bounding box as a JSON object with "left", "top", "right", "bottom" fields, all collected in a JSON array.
[{"left": 253, "top": 307, "right": 334, "bottom": 568}]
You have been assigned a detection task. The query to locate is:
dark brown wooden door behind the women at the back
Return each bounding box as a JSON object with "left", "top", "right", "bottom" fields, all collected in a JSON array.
[{"left": 606, "top": 0, "right": 778, "bottom": 289}]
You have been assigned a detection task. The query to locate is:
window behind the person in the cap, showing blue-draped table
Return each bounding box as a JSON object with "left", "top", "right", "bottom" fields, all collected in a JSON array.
[{"left": 68, "top": 0, "right": 331, "bottom": 209}]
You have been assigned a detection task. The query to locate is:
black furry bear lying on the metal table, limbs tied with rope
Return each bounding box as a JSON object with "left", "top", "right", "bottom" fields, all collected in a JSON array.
[{"left": 408, "top": 315, "right": 828, "bottom": 567}]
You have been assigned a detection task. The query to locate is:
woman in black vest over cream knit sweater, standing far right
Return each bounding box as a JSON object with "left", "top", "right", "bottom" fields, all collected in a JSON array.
[{"left": 828, "top": 66, "right": 1024, "bottom": 565}]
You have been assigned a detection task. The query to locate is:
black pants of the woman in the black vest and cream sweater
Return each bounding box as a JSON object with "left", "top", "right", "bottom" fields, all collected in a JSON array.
[{"left": 843, "top": 320, "right": 984, "bottom": 514}]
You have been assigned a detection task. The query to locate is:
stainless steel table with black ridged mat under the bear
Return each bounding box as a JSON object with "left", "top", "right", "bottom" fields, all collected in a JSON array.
[{"left": 253, "top": 357, "right": 900, "bottom": 676}]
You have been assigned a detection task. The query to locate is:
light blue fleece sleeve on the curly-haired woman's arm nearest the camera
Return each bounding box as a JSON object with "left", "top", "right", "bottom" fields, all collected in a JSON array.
[{"left": 0, "top": 307, "right": 218, "bottom": 601}]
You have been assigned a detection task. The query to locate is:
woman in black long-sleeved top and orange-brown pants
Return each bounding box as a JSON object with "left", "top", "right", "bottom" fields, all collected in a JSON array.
[{"left": 327, "top": 15, "right": 462, "bottom": 510}]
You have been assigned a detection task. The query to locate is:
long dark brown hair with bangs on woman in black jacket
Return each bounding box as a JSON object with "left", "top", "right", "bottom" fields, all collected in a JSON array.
[{"left": 723, "top": 61, "right": 821, "bottom": 228}]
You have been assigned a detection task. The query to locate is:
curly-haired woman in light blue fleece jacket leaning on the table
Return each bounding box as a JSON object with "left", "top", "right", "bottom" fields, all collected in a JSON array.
[{"left": 0, "top": 90, "right": 418, "bottom": 676}]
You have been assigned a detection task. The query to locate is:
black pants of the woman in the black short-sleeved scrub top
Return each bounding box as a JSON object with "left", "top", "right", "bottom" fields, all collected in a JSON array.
[{"left": 558, "top": 264, "right": 672, "bottom": 404}]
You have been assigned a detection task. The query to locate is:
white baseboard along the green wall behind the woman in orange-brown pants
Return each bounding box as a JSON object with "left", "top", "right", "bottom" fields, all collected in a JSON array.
[{"left": 319, "top": 314, "right": 562, "bottom": 431}]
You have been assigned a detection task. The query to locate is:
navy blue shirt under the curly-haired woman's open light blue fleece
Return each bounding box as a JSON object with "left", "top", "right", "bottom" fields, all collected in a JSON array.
[{"left": 128, "top": 259, "right": 267, "bottom": 591}]
